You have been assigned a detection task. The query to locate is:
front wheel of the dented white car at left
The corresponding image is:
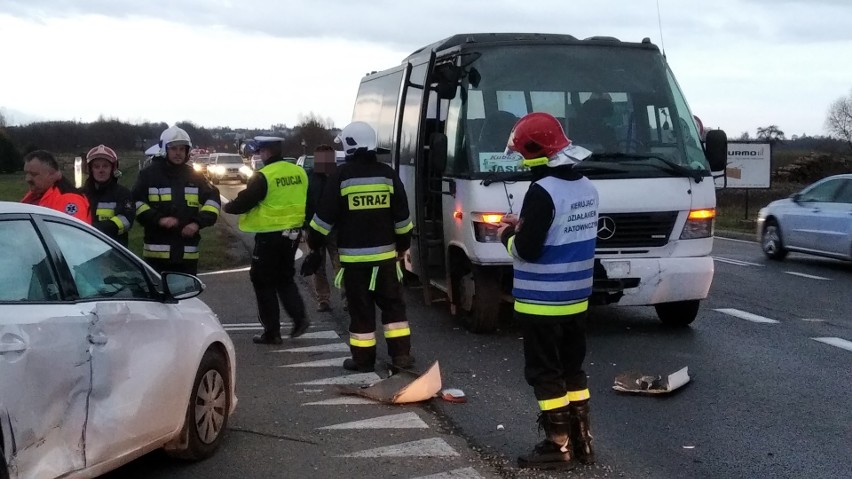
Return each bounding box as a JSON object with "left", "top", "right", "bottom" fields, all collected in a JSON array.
[{"left": 166, "top": 350, "right": 231, "bottom": 461}]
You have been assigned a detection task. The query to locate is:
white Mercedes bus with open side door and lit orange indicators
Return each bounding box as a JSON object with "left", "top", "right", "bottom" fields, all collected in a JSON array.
[{"left": 352, "top": 33, "right": 727, "bottom": 332}]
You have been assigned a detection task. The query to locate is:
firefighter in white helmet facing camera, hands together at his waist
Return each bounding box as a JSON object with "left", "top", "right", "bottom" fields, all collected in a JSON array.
[{"left": 132, "top": 126, "right": 221, "bottom": 274}]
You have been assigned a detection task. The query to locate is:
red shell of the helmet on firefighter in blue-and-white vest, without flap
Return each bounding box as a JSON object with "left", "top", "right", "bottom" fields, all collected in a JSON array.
[{"left": 506, "top": 112, "right": 571, "bottom": 160}]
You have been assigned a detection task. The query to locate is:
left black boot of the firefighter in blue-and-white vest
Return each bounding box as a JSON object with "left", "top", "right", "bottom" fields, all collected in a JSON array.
[{"left": 518, "top": 412, "right": 574, "bottom": 470}]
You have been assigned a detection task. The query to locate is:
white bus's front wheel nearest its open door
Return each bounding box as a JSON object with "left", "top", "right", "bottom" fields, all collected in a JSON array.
[{"left": 458, "top": 265, "right": 502, "bottom": 333}]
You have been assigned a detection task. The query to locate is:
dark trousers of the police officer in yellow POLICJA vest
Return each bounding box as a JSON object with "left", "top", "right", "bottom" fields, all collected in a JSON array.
[{"left": 249, "top": 233, "right": 305, "bottom": 335}]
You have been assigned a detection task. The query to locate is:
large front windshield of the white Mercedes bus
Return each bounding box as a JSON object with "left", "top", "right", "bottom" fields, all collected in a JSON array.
[{"left": 448, "top": 45, "right": 710, "bottom": 178}]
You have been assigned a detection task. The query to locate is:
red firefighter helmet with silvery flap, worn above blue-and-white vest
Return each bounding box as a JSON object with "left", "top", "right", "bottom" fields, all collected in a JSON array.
[{"left": 506, "top": 112, "right": 591, "bottom": 167}]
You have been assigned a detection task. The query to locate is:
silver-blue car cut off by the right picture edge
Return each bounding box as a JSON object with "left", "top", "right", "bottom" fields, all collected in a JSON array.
[{"left": 757, "top": 174, "right": 852, "bottom": 260}]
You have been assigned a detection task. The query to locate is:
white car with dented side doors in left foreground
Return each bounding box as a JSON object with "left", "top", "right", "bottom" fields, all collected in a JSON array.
[{"left": 0, "top": 202, "right": 237, "bottom": 479}]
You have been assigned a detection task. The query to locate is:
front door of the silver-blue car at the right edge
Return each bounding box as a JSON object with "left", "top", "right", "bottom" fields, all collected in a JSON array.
[{"left": 781, "top": 178, "right": 842, "bottom": 251}]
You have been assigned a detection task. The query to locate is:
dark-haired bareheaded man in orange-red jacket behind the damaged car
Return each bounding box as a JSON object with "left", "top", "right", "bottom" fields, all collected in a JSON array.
[{"left": 21, "top": 150, "right": 92, "bottom": 224}]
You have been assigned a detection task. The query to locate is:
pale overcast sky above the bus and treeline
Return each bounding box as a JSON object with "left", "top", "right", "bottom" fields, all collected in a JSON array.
[{"left": 0, "top": 0, "right": 852, "bottom": 137}]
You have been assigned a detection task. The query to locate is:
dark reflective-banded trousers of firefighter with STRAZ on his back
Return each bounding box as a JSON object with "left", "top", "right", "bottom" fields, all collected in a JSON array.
[{"left": 343, "top": 262, "right": 411, "bottom": 366}]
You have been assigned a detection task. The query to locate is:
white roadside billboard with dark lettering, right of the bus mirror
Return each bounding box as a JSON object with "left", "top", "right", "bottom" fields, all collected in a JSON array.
[{"left": 715, "top": 141, "right": 772, "bottom": 188}]
